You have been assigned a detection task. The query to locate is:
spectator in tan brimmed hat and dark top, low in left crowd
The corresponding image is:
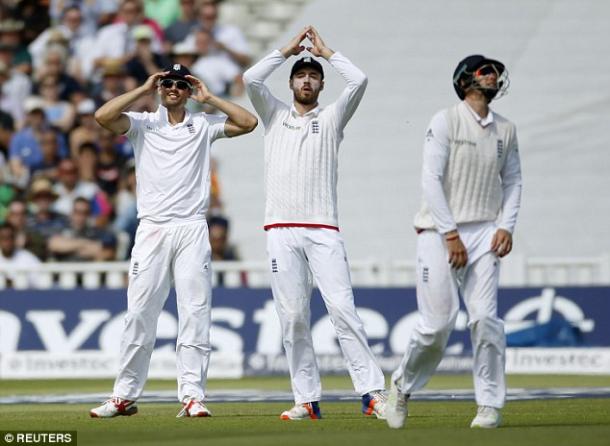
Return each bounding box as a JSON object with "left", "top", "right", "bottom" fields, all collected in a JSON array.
[{"left": 26, "top": 177, "right": 69, "bottom": 260}]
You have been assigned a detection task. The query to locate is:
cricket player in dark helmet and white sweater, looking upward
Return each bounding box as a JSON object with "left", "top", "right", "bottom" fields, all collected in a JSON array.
[{"left": 386, "top": 55, "right": 521, "bottom": 428}]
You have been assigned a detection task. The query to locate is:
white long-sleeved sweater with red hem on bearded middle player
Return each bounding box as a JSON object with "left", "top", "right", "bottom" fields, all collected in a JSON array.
[{"left": 244, "top": 50, "right": 367, "bottom": 229}]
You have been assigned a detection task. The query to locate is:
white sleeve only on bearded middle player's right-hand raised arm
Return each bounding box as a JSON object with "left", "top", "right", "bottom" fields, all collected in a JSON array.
[{"left": 328, "top": 52, "right": 368, "bottom": 132}]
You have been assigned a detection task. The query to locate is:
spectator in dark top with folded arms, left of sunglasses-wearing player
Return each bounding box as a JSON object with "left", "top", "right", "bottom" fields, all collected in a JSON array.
[{"left": 47, "top": 197, "right": 117, "bottom": 262}]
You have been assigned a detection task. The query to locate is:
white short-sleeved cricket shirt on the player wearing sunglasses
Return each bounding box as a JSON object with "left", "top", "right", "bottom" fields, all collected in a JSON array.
[{"left": 125, "top": 105, "right": 227, "bottom": 224}]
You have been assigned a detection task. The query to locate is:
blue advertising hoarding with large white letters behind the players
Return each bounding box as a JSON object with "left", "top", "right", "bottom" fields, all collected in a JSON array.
[{"left": 0, "top": 287, "right": 610, "bottom": 374}]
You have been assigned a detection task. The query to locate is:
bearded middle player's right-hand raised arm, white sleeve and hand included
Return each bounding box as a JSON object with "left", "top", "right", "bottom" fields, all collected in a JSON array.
[{"left": 307, "top": 27, "right": 368, "bottom": 130}]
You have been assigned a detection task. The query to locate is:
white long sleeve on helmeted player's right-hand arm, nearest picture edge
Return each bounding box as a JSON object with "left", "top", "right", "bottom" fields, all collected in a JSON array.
[{"left": 498, "top": 124, "right": 522, "bottom": 234}]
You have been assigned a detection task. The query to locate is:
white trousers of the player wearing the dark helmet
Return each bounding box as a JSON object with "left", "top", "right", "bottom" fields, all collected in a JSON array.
[{"left": 392, "top": 231, "right": 506, "bottom": 409}]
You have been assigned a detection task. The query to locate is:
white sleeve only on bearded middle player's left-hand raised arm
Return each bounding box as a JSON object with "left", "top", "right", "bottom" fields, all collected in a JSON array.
[{"left": 244, "top": 50, "right": 286, "bottom": 127}]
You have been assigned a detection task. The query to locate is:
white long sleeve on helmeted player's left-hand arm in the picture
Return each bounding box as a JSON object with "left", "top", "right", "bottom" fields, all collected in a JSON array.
[{"left": 422, "top": 112, "right": 457, "bottom": 234}]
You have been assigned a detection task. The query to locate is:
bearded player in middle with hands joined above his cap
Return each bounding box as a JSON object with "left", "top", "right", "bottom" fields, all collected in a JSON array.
[{"left": 244, "top": 26, "right": 385, "bottom": 420}]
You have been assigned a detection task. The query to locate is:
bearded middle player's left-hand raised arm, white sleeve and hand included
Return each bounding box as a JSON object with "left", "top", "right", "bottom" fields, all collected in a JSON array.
[{"left": 243, "top": 26, "right": 311, "bottom": 127}]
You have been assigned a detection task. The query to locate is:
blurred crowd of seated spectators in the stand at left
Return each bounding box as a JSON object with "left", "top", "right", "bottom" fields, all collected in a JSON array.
[{"left": 0, "top": 0, "right": 251, "bottom": 285}]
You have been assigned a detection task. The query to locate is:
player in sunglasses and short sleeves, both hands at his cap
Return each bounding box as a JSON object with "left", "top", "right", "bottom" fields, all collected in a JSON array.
[{"left": 90, "top": 64, "right": 257, "bottom": 418}]
